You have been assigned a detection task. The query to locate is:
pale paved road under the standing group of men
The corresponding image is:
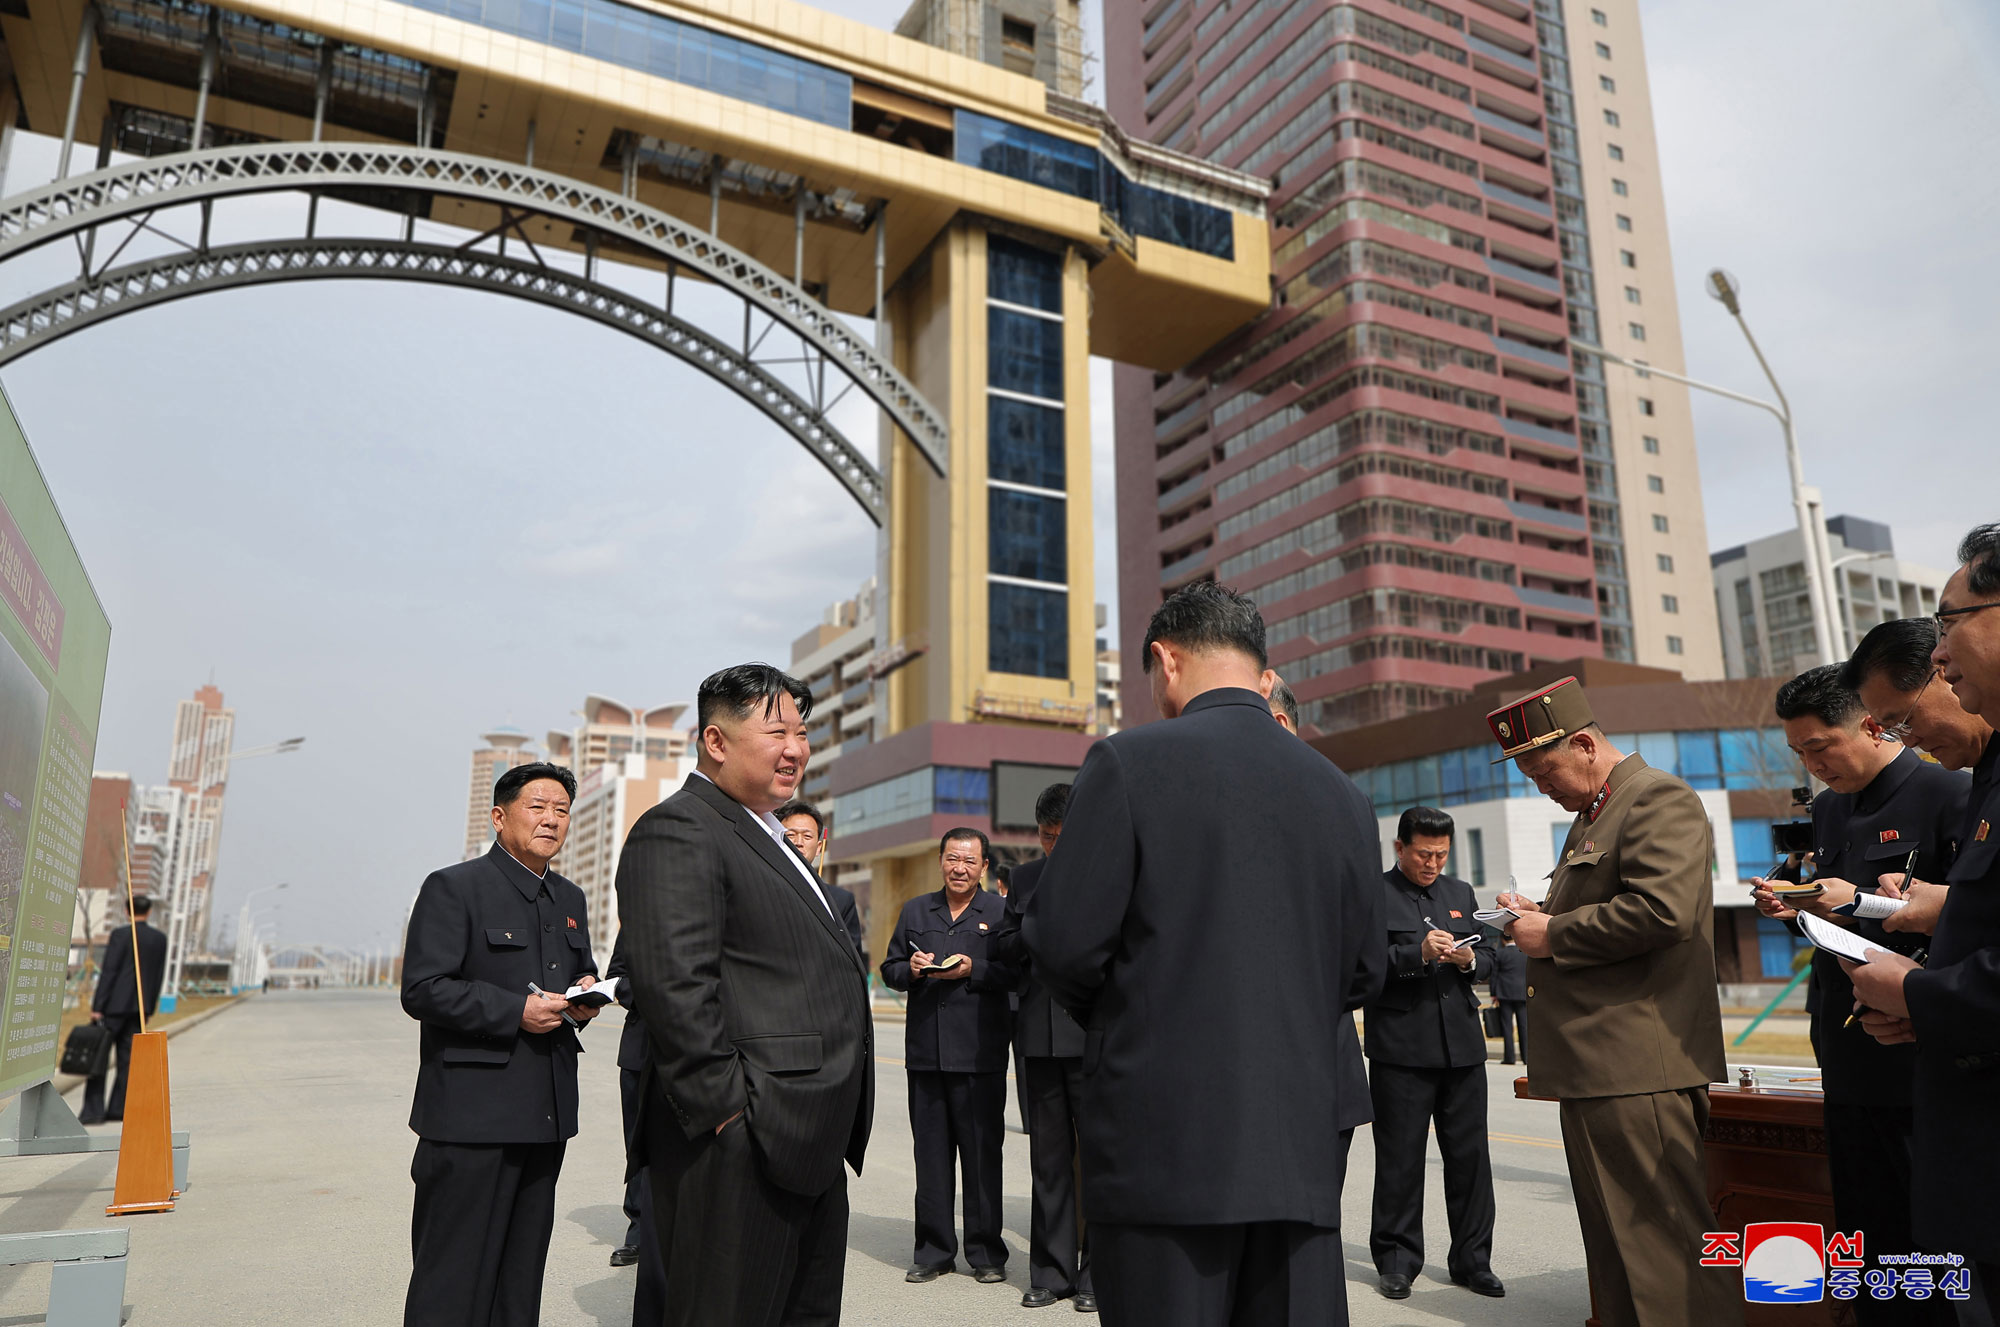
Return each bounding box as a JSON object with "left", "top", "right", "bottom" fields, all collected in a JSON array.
[{"left": 0, "top": 991, "right": 1586, "bottom": 1327}]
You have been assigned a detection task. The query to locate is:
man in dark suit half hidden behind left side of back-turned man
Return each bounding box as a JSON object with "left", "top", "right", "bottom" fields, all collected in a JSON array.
[{"left": 1002, "top": 783, "right": 1098, "bottom": 1313}]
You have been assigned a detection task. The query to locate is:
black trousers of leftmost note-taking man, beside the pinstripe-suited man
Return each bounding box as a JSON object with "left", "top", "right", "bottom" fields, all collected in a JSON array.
[{"left": 402, "top": 1137, "right": 564, "bottom": 1327}]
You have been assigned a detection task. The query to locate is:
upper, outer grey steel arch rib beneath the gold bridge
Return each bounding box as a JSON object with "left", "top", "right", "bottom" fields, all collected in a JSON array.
[{"left": 0, "top": 142, "right": 948, "bottom": 507}]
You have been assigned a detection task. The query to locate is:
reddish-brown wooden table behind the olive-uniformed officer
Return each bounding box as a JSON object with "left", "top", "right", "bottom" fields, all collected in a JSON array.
[{"left": 1514, "top": 1077, "right": 1854, "bottom": 1327}]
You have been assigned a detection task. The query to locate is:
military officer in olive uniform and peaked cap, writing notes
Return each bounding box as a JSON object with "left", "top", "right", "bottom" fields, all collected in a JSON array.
[{"left": 1486, "top": 677, "right": 1744, "bottom": 1327}]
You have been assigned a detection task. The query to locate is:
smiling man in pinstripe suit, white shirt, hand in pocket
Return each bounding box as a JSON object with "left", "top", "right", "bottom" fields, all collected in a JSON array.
[{"left": 618, "top": 664, "right": 874, "bottom": 1327}]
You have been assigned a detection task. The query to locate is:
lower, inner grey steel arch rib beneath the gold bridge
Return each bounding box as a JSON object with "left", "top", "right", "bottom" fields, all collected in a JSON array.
[{"left": 0, "top": 240, "right": 884, "bottom": 511}]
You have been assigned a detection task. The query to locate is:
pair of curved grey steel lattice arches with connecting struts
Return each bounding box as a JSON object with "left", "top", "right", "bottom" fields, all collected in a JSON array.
[{"left": 0, "top": 142, "right": 948, "bottom": 524}]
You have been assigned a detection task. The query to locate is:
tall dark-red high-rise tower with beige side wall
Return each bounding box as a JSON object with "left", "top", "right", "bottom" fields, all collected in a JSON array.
[{"left": 1106, "top": 0, "right": 1720, "bottom": 729}]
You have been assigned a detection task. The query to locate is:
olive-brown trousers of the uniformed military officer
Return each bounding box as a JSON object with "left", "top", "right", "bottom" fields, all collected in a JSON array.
[{"left": 1560, "top": 1087, "right": 1744, "bottom": 1327}]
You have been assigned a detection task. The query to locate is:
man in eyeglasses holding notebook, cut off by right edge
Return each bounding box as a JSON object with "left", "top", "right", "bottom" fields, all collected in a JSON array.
[{"left": 1844, "top": 524, "right": 2000, "bottom": 1301}]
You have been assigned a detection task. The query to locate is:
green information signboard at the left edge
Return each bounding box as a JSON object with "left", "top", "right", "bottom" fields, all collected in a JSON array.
[{"left": 0, "top": 381, "right": 112, "bottom": 1093}]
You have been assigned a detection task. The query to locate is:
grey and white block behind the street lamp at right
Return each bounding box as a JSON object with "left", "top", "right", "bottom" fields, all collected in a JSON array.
[{"left": 1708, "top": 516, "right": 1950, "bottom": 677}]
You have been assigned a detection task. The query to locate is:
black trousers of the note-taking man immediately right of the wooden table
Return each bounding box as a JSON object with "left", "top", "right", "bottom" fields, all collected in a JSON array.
[{"left": 1824, "top": 1103, "right": 1958, "bottom": 1327}]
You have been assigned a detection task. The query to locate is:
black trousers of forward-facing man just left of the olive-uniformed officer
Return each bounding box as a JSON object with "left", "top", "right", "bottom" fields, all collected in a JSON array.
[{"left": 1368, "top": 1059, "right": 1494, "bottom": 1281}]
